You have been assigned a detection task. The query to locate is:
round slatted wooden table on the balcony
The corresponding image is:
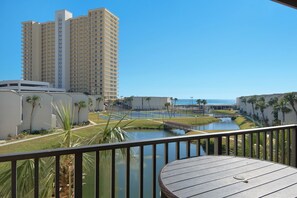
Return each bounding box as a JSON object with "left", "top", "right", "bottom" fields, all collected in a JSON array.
[{"left": 159, "top": 156, "right": 297, "bottom": 198}]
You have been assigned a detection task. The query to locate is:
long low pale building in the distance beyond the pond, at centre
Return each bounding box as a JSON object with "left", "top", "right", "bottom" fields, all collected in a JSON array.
[{"left": 131, "top": 97, "right": 171, "bottom": 110}]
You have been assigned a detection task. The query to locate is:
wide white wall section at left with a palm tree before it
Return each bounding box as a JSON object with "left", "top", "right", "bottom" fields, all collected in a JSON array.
[{"left": 19, "top": 92, "right": 53, "bottom": 131}]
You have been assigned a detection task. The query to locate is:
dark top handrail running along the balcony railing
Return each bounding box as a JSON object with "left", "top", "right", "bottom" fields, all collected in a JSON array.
[{"left": 0, "top": 124, "right": 297, "bottom": 162}]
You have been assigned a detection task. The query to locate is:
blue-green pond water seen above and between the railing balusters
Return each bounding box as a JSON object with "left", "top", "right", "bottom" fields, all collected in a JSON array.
[{"left": 83, "top": 118, "right": 238, "bottom": 198}]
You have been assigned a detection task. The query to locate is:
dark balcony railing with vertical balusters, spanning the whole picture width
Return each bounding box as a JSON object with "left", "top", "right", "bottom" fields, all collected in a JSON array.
[{"left": 0, "top": 125, "right": 297, "bottom": 197}]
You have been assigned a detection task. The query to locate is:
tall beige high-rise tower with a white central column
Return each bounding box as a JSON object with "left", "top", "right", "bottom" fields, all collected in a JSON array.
[{"left": 22, "top": 8, "right": 119, "bottom": 99}]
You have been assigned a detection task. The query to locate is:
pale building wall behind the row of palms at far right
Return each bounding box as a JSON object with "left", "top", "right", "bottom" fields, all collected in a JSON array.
[{"left": 236, "top": 94, "right": 297, "bottom": 125}]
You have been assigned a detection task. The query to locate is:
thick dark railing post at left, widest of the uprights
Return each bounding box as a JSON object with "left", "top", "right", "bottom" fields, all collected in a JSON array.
[{"left": 74, "top": 153, "right": 82, "bottom": 198}]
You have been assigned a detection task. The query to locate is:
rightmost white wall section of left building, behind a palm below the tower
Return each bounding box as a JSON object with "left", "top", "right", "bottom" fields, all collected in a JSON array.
[{"left": 69, "top": 93, "right": 89, "bottom": 123}]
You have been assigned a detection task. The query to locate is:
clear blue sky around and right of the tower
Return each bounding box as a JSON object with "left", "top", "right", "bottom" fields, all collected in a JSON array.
[{"left": 0, "top": 0, "right": 297, "bottom": 99}]
